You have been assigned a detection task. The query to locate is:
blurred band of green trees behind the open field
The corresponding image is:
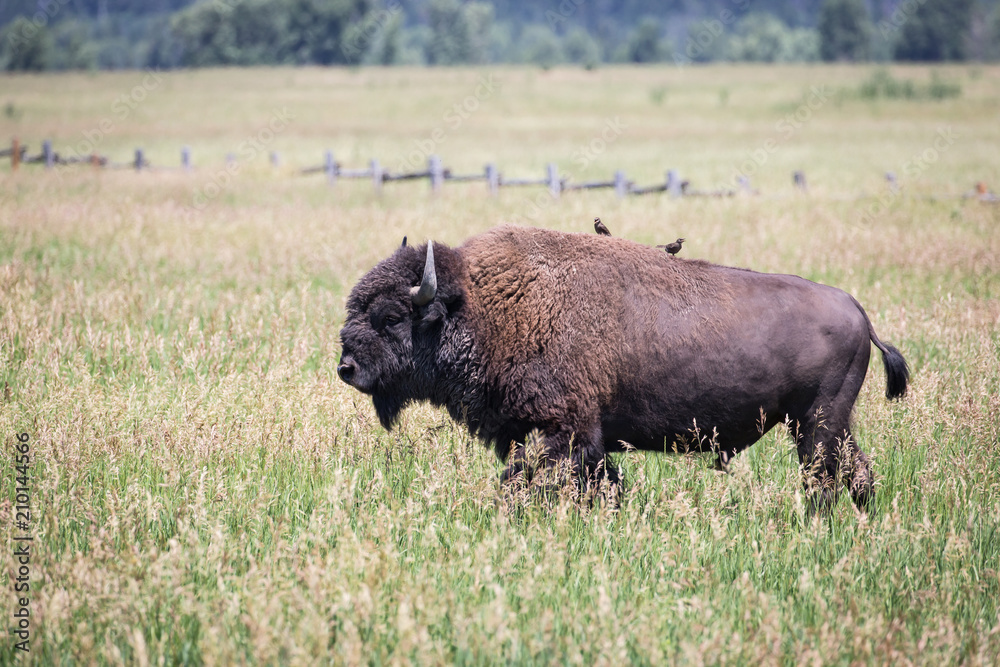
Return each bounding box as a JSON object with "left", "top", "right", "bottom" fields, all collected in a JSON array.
[{"left": 0, "top": 0, "right": 1000, "bottom": 71}]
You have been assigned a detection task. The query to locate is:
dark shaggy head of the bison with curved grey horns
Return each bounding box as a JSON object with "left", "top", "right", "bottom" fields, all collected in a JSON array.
[{"left": 337, "top": 242, "right": 455, "bottom": 428}]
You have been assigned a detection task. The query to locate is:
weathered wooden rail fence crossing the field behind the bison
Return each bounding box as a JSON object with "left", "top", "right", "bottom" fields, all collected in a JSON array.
[{"left": 7, "top": 138, "right": 1000, "bottom": 203}]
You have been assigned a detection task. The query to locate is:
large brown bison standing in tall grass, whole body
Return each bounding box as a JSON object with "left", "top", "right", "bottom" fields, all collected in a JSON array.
[{"left": 337, "top": 226, "right": 908, "bottom": 508}]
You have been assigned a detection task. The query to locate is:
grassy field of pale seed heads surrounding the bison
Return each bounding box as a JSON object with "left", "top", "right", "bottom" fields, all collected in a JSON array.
[{"left": 0, "top": 66, "right": 1000, "bottom": 665}]
